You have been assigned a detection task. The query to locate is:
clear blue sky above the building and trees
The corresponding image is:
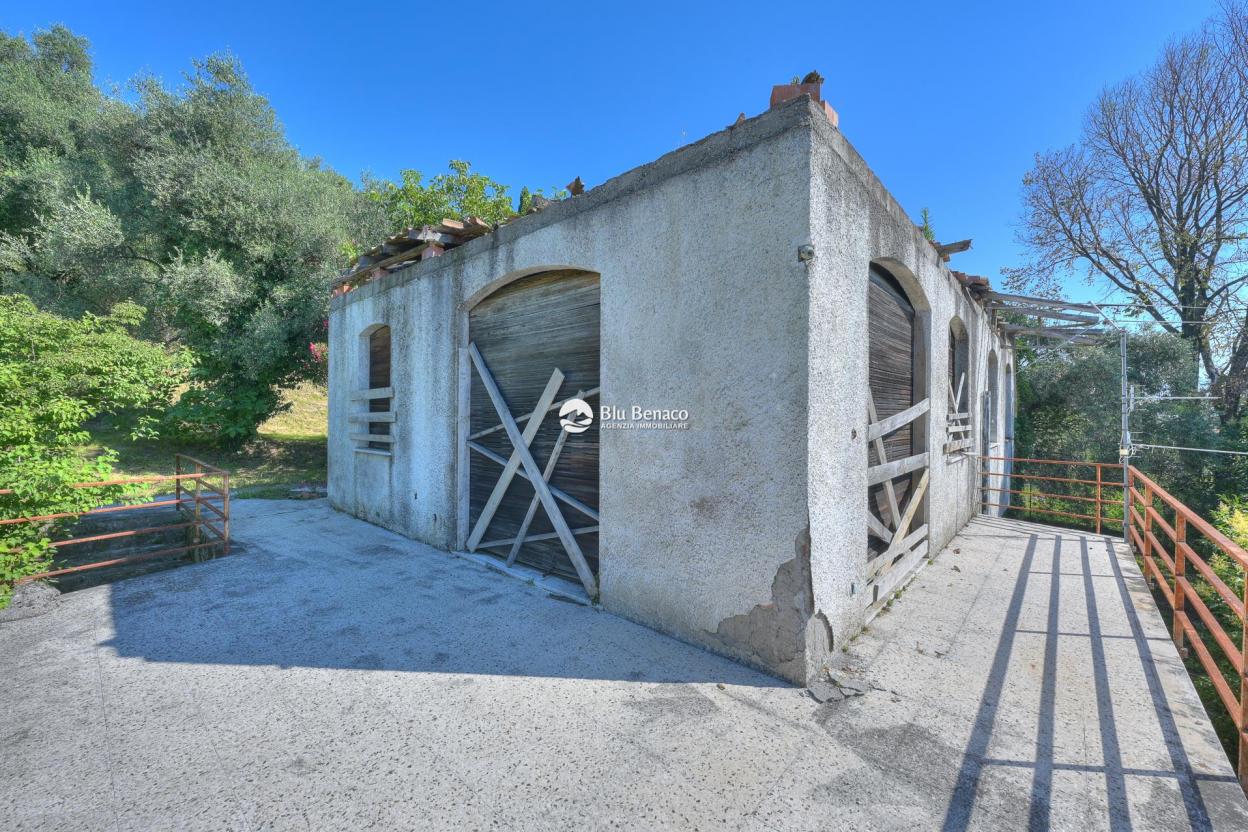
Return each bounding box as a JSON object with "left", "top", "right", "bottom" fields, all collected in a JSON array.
[{"left": 0, "top": 0, "right": 1216, "bottom": 298}]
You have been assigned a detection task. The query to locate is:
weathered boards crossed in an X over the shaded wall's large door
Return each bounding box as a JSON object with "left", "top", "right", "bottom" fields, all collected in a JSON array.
[{"left": 468, "top": 343, "right": 598, "bottom": 597}]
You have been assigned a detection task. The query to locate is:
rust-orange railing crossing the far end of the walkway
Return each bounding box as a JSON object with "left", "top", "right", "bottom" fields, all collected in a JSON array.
[{"left": 980, "top": 457, "right": 1123, "bottom": 534}]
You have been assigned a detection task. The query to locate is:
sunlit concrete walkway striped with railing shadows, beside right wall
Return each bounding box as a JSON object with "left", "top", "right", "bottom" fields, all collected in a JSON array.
[{"left": 825, "top": 518, "right": 1248, "bottom": 832}]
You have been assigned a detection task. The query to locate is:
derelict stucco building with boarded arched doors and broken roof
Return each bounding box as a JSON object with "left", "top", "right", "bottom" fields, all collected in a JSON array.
[{"left": 329, "top": 82, "right": 1013, "bottom": 684}]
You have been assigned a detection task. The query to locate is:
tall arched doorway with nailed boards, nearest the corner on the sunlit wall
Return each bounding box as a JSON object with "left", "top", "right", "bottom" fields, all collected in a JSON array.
[{"left": 866, "top": 264, "right": 930, "bottom": 600}]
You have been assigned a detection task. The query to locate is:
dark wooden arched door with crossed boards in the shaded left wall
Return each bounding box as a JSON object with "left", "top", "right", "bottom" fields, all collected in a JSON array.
[{"left": 468, "top": 271, "right": 599, "bottom": 589}]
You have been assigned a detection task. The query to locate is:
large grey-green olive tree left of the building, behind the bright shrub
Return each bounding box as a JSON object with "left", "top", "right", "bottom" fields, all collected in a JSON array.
[{"left": 0, "top": 26, "right": 386, "bottom": 440}]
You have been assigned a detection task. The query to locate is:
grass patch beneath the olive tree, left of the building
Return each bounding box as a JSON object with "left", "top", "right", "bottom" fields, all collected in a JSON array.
[{"left": 82, "top": 384, "right": 328, "bottom": 498}]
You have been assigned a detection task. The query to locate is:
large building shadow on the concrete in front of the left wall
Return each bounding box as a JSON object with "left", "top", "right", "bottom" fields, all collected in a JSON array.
[{"left": 105, "top": 500, "right": 787, "bottom": 687}]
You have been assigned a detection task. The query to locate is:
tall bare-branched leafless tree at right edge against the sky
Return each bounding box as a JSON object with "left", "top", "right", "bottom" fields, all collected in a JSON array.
[{"left": 1006, "top": 0, "right": 1248, "bottom": 419}]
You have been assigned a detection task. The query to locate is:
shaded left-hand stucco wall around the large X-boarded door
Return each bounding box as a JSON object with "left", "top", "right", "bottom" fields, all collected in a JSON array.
[{"left": 329, "top": 99, "right": 810, "bottom": 672}]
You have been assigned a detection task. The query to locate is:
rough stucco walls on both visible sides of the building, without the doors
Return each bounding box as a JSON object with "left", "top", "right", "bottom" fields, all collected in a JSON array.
[{"left": 329, "top": 100, "right": 1005, "bottom": 681}]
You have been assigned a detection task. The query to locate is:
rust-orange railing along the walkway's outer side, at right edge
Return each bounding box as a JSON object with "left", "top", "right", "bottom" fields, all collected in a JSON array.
[{"left": 1128, "top": 465, "right": 1248, "bottom": 791}]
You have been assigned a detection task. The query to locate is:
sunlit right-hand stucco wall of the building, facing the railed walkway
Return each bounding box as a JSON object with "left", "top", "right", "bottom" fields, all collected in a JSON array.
[{"left": 807, "top": 109, "right": 1012, "bottom": 661}]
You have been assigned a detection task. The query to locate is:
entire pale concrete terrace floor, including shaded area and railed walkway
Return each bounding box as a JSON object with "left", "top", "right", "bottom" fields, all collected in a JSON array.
[{"left": 0, "top": 500, "right": 1248, "bottom": 832}]
